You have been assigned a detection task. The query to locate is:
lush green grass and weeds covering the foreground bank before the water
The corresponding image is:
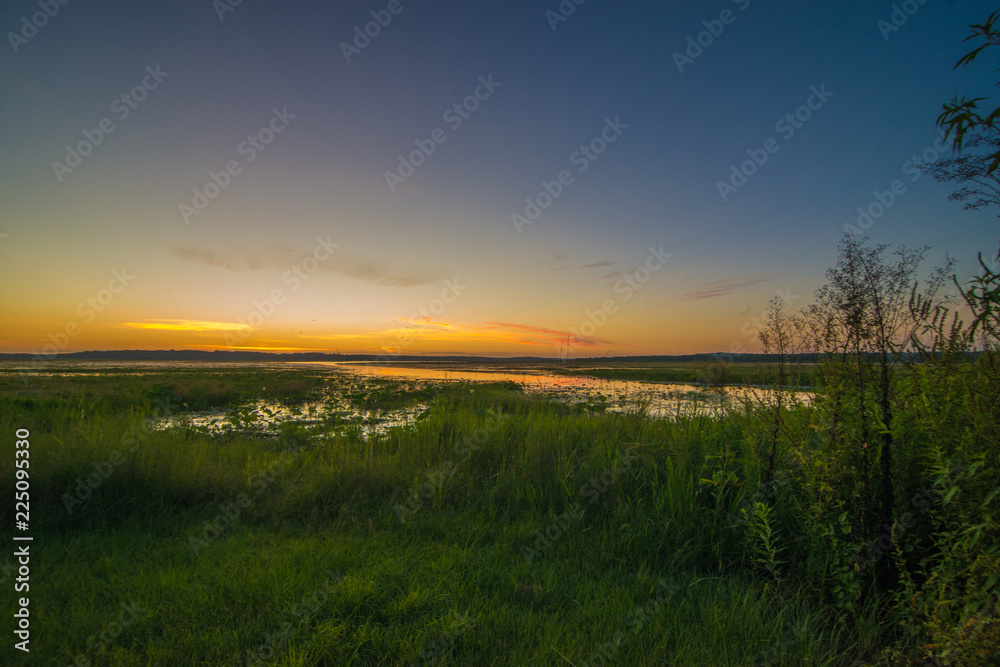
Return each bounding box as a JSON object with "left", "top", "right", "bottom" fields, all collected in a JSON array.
[{"left": 0, "top": 362, "right": 997, "bottom": 665}]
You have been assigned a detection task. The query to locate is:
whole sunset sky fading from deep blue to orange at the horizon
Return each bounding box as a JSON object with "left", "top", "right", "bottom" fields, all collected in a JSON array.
[{"left": 0, "top": 0, "right": 1000, "bottom": 358}]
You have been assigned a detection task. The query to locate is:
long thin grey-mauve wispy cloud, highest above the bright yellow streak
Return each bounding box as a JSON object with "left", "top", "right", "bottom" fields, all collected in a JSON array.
[{"left": 170, "top": 246, "right": 441, "bottom": 287}]
